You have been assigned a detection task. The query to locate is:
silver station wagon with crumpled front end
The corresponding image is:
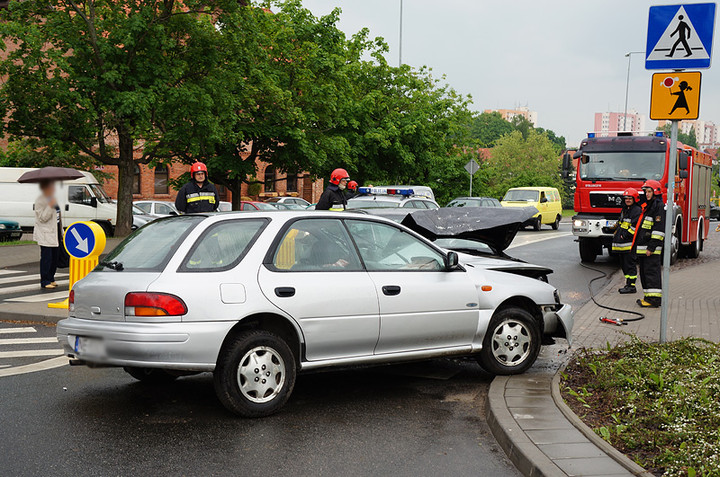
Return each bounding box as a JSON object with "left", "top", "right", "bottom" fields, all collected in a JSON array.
[{"left": 57, "top": 211, "right": 573, "bottom": 417}]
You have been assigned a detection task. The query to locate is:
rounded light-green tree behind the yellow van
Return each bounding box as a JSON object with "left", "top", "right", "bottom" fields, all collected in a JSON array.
[{"left": 486, "top": 129, "right": 564, "bottom": 198}]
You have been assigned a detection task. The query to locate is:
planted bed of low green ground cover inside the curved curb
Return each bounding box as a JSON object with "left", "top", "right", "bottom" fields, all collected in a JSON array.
[{"left": 561, "top": 338, "right": 720, "bottom": 477}]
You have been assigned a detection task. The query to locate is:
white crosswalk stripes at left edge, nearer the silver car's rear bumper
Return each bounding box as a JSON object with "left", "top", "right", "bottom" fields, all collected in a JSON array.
[{"left": 0, "top": 323, "right": 68, "bottom": 378}]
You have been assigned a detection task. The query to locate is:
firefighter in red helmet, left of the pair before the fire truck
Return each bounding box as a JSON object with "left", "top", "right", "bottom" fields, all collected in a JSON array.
[{"left": 612, "top": 187, "right": 642, "bottom": 294}]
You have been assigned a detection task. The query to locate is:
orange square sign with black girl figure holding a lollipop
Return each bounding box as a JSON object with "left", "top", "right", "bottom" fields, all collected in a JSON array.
[{"left": 650, "top": 71, "right": 702, "bottom": 120}]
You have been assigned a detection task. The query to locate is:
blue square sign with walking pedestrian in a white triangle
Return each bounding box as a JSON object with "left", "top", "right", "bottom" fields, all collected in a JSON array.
[{"left": 645, "top": 3, "right": 715, "bottom": 70}]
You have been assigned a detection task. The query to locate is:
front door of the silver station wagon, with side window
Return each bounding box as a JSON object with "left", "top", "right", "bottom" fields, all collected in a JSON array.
[{"left": 346, "top": 219, "right": 479, "bottom": 354}]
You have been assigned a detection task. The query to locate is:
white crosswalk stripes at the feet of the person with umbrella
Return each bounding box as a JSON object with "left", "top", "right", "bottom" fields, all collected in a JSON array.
[{"left": 0, "top": 269, "right": 69, "bottom": 303}]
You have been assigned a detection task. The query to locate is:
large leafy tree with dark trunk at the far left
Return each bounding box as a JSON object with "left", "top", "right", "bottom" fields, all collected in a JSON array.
[{"left": 0, "top": 0, "right": 239, "bottom": 235}]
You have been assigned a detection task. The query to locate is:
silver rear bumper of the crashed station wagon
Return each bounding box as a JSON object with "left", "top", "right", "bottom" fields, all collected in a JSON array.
[{"left": 57, "top": 318, "right": 235, "bottom": 371}]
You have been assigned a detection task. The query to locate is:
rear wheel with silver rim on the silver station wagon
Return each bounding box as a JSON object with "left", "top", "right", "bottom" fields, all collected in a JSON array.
[{"left": 213, "top": 330, "right": 297, "bottom": 417}]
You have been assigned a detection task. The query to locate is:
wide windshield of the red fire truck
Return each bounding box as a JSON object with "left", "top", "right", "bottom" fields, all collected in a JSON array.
[{"left": 578, "top": 152, "right": 665, "bottom": 181}]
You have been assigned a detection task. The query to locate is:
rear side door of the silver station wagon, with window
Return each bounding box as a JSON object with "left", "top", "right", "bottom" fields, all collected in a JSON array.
[{"left": 258, "top": 219, "right": 380, "bottom": 361}]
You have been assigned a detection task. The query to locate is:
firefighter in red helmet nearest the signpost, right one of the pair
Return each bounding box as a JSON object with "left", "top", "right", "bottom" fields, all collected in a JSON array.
[{"left": 635, "top": 180, "right": 665, "bottom": 308}]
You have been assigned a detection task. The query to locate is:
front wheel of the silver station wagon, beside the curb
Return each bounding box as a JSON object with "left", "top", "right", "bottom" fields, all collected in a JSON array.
[{"left": 478, "top": 307, "right": 542, "bottom": 375}]
